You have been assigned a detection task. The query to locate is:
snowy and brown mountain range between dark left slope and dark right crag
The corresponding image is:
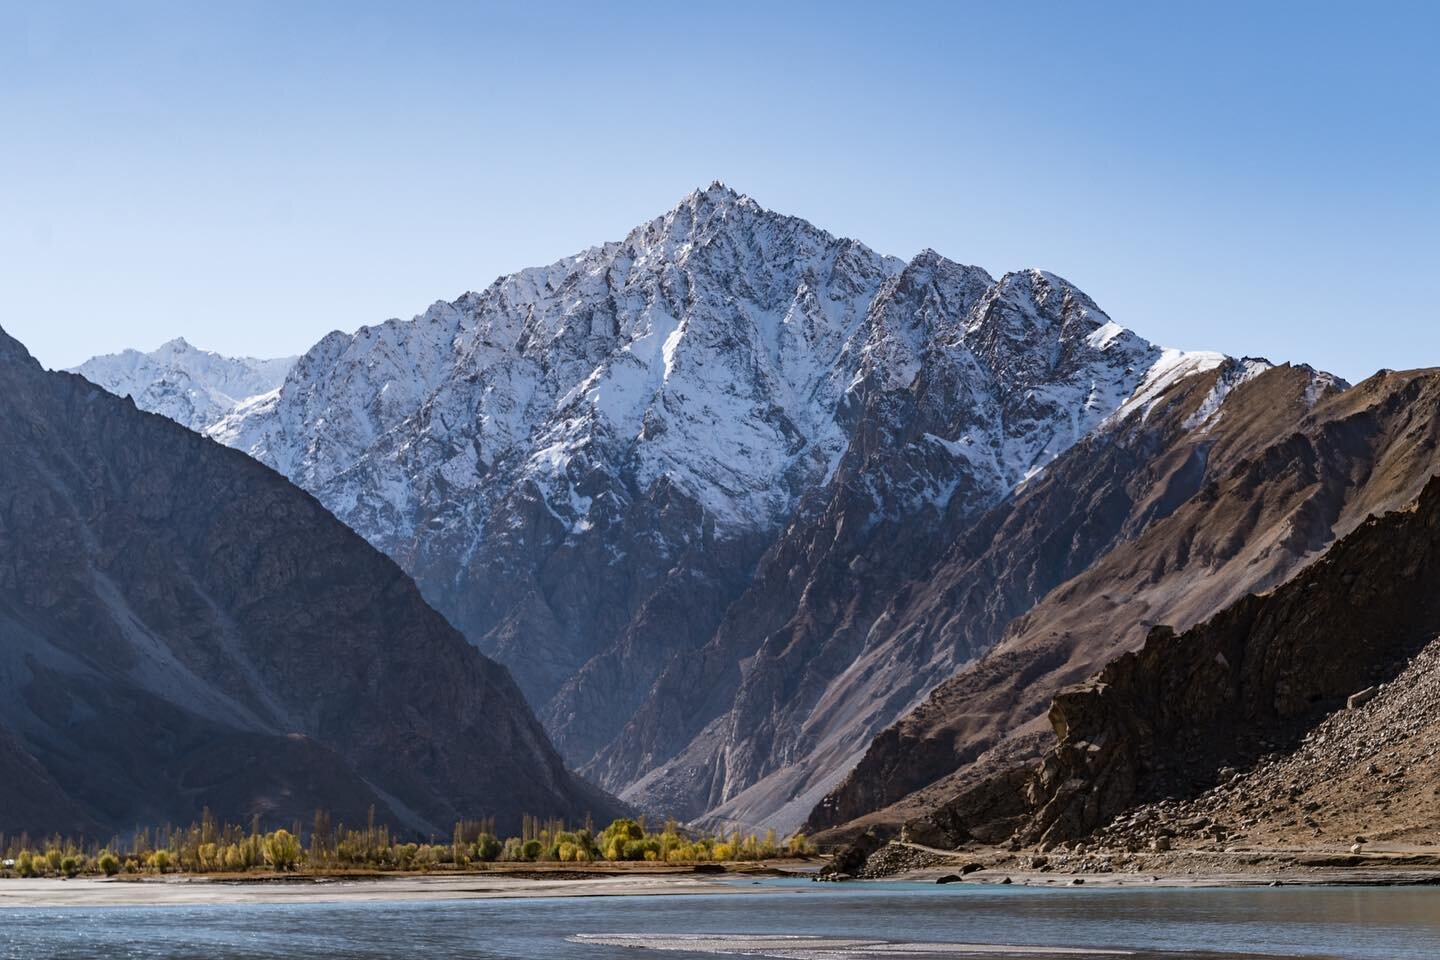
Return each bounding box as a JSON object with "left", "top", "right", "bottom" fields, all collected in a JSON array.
[{"left": 59, "top": 183, "right": 1440, "bottom": 842}]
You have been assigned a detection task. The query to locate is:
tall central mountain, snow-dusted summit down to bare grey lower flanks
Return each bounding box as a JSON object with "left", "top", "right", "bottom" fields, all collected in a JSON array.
[{"left": 84, "top": 184, "right": 1224, "bottom": 826}]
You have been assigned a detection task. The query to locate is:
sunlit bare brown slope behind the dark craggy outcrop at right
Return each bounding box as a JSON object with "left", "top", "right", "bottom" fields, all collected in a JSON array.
[{"left": 811, "top": 368, "right": 1440, "bottom": 832}]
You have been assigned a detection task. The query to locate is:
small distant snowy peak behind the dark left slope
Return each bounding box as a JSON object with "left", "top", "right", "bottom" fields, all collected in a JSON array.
[{"left": 71, "top": 338, "right": 295, "bottom": 430}]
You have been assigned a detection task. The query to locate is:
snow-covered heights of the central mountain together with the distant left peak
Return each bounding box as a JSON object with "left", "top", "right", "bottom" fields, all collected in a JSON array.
[{"left": 79, "top": 183, "right": 1255, "bottom": 604}]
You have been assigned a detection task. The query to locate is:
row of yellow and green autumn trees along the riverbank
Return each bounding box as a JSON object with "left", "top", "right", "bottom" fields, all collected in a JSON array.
[{"left": 0, "top": 809, "right": 814, "bottom": 877}]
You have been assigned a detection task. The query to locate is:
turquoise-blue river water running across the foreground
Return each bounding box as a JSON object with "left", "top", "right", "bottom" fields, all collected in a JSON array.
[{"left": 0, "top": 881, "right": 1440, "bottom": 960}]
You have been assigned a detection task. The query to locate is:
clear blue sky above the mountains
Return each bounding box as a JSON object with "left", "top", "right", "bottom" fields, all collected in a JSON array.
[{"left": 0, "top": 0, "right": 1440, "bottom": 379}]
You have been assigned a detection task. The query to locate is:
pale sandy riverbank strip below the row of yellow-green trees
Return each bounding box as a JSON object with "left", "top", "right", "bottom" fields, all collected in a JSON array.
[{"left": 0, "top": 874, "right": 800, "bottom": 910}]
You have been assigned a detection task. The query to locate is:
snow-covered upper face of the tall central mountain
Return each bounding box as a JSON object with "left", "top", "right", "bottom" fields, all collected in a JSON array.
[{"left": 212, "top": 188, "right": 1192, "bottom": 546}]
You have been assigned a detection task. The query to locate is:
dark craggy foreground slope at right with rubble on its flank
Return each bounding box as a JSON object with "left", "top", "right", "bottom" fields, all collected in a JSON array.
[{"left": 927, "top": 469, "right": 1440, "bottom": 843}]
